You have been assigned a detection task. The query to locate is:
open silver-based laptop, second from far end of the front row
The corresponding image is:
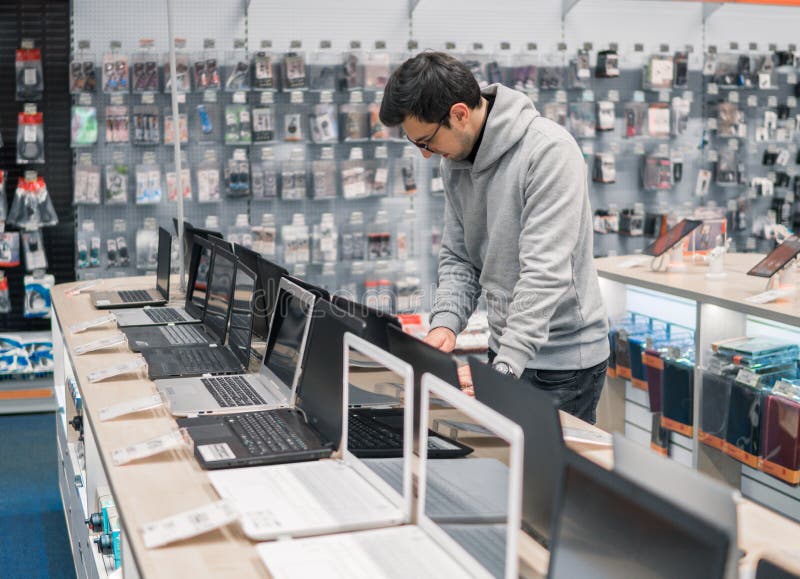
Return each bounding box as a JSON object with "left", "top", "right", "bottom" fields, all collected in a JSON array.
[{"left": 111, "top": 238, "right": 213, "bottom": 328}]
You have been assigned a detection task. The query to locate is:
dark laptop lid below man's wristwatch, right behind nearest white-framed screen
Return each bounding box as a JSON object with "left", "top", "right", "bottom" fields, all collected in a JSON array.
[{"left": 469, "top": 356, "right": 567, "bottom": 546}]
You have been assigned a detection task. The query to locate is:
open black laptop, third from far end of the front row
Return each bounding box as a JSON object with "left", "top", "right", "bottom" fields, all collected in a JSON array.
[{"left": 122, "top": 242, "right": 236, "bottom": 352}]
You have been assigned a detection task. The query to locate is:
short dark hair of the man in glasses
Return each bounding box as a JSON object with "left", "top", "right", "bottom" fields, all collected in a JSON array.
[{"left": 380, "top": 52, "right": 481, "bottom": 127}]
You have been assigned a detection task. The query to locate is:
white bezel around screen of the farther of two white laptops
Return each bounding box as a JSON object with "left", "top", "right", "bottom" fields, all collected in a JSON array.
[{"left": 337, "top": 332, "right": 412, "bottom": 523}]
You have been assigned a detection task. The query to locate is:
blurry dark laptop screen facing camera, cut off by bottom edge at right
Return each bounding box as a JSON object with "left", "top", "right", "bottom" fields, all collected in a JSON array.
[{"left": 547, "top": 452, "right": 729, "bottom": 579}]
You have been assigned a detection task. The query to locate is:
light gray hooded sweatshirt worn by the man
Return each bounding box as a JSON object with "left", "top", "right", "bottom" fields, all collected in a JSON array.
[{"left": 431, "top": 85, "right": 609, "bottom": 376}]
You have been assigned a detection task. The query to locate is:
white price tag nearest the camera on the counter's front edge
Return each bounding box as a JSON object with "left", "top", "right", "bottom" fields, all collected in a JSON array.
[{"left": 142, "top": 501, "right": 239, "bottom": 549}]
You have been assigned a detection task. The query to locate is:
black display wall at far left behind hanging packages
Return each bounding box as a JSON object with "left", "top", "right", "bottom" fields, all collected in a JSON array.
[{"left": 0, "top": 0, "right": 75, "bottom": 332}]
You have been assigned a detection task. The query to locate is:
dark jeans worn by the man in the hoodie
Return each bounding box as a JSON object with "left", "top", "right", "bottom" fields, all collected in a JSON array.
[{"left": 489, "top": 350, "right": 608, "bottom": 424}]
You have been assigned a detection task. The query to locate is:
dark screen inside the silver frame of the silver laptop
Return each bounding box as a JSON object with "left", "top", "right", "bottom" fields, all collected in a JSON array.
[{"left": 264, "top": 290, "right": 308, "bottom": 386}]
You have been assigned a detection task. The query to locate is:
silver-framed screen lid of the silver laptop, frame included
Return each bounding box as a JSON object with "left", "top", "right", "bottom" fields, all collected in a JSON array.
[{"left": 260, "top": 278, "right": 316, "bottom": 404}]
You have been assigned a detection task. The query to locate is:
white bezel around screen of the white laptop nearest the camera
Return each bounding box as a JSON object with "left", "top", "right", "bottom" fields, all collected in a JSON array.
[{"left": 417, "top": 373, "right": 524, "bottom": 579}]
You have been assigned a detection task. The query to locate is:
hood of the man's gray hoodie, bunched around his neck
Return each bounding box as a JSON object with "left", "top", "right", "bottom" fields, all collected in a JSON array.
[{"left": 442, "top": 84, "right": 541, "bottom": 171}]
